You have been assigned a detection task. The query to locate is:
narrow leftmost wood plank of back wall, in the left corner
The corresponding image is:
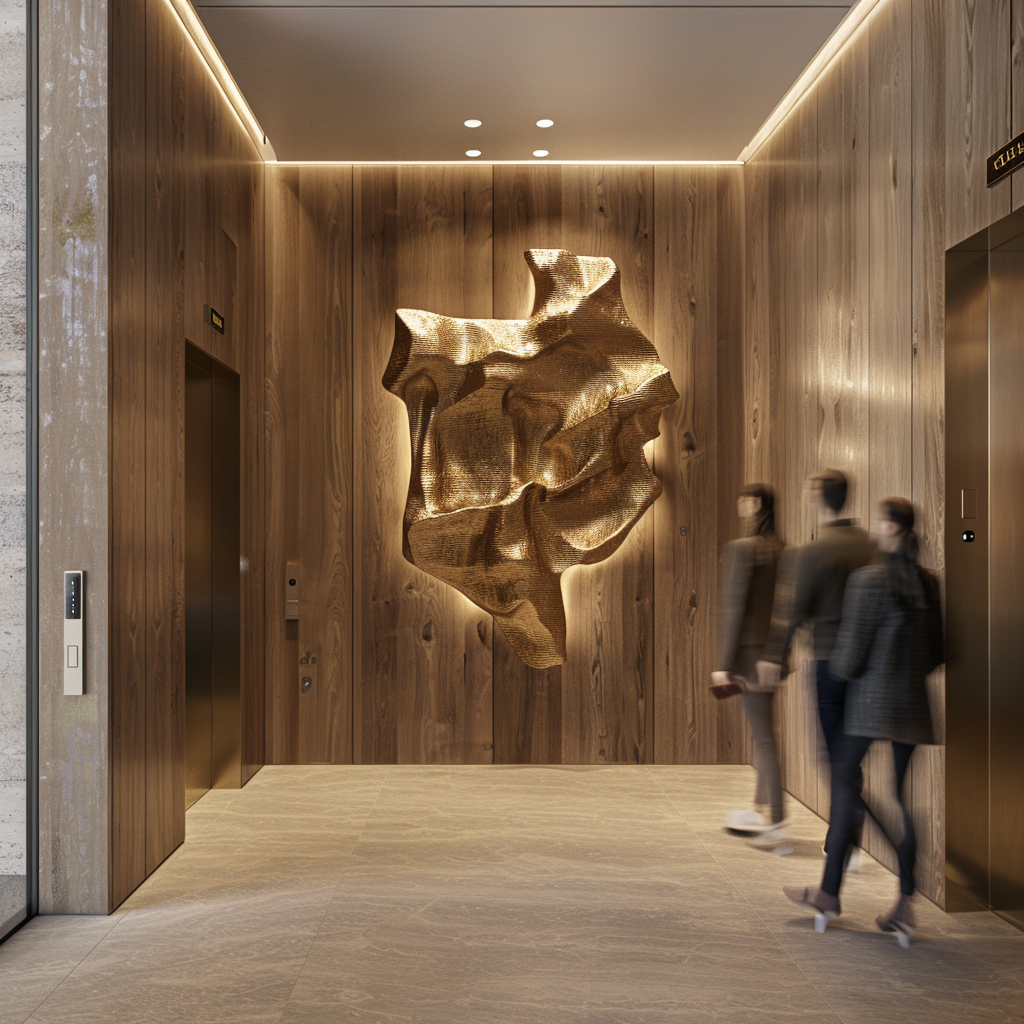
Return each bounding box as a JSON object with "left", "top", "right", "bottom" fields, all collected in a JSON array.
[{"left": 263, "top": 167, "right": 301, "bottom": 764}]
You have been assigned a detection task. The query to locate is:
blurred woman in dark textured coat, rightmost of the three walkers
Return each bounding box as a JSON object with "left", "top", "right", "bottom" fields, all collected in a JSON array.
[{"left": 784, "top": 498, "right": 944, "bottom": 947}]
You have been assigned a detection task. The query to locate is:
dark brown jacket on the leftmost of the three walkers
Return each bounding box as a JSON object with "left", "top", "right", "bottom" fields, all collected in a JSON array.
[{"left": 717, "top": 537, "right": 782, "bottom": 677}]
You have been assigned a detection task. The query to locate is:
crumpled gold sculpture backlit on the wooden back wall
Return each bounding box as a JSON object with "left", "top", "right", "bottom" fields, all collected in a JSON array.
[{"left": 383, "top": 249, "right": 679, "bottom": 669}]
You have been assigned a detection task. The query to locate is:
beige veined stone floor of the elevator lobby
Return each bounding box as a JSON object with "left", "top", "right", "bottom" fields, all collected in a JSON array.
[{"left": 0, "top": 767, "right": 1024, "bottom": 1024}]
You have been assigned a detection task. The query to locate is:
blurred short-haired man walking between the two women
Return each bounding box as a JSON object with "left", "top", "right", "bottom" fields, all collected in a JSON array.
[{"left": 757, "top": 469, "right": 876, "bottom": 870}]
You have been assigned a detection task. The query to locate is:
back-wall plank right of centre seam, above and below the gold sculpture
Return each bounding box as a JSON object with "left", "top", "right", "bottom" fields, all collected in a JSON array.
[{"left": 492, "top": 164, "right": 562, "bottom": 764}]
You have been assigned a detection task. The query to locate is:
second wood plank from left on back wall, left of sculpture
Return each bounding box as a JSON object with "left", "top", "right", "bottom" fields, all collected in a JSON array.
[{"left": 299, "top": 167, "right": 352, "bottom": 764}]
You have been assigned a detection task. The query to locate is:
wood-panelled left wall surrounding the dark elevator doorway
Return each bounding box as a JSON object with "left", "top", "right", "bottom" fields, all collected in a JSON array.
[{"left": 109, "top": 0, "right": 265, "bottom": 908}]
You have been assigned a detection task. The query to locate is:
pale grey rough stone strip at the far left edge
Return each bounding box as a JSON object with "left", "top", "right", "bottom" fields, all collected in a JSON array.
[{"left": 0, "top": 3, "right": 27, "bottom": 880}]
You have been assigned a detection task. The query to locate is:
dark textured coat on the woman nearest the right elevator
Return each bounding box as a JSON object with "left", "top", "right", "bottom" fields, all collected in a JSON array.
[{"left": 828, "top": 565, "right": 945, "bottom": 743}]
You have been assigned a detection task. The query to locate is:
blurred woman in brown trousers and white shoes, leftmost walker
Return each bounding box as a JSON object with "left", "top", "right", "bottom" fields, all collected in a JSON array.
[{"left": 711, "top": 483, "right": 785, "bottom": 839}]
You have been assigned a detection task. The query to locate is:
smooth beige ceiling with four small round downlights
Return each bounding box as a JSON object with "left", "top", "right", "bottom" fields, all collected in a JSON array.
[{"left": 197, "top": 0, "right": 851, "bottom": 163}]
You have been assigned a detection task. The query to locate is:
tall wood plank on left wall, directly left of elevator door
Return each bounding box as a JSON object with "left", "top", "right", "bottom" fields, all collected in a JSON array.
[{"left": 145, "top": 0, "right": 185, "bottom": 871}]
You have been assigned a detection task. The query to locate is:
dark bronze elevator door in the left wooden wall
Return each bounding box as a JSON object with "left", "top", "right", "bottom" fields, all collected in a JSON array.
[{"left": 185, "top": 342, "right": 242, "bottom": 806}]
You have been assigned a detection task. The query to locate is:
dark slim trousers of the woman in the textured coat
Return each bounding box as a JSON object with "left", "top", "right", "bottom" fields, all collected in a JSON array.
[{"left": 821, "top": 735, "right": 918, "bottom": 896}]
